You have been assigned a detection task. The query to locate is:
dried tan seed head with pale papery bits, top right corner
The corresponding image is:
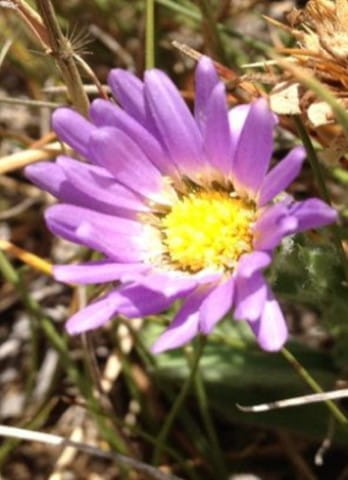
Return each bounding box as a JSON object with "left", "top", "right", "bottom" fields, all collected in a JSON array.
[{"left": 270, "top": 0, "right": 348, "bottom": 136}]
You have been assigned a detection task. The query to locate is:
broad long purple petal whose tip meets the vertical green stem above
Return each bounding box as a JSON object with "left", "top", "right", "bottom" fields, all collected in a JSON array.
[{"left": 145, "top": 70, "right": 202, "bottom": 175}]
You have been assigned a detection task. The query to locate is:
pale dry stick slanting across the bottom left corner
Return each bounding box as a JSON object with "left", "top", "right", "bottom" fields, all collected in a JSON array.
[{"left": 0, "top": 425, "right": 183, "bottom": 480}]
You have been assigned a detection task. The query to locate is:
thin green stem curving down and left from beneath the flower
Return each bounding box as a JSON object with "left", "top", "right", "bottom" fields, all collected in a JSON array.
[{"left": 152, "top": 339, "right": 205, "bottom": 465}]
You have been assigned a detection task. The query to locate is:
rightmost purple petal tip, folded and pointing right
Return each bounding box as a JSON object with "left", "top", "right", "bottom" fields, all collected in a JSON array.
[{"left": 290, "top": 198, "right": 338, "bottom": 232}]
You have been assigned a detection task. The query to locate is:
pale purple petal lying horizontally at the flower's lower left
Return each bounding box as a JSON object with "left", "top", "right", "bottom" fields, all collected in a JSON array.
[{"left": 53, "top": 260, "right": 149, "bottom": 285}]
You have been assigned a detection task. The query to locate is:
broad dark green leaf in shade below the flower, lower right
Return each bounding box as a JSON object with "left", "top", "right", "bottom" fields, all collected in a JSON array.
[{"left": 143, "top": 320, "right": 348, "bottom": 442}]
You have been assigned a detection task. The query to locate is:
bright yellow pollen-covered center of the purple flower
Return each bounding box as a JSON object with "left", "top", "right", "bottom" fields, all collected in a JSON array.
[{"left": 161, "top": 191, "right": 255, "bottom": 272}]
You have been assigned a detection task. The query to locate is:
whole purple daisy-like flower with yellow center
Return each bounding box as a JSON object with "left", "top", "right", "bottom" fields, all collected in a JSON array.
[{"left": 26, "top": 57, "right": 336, "bottom": 352}]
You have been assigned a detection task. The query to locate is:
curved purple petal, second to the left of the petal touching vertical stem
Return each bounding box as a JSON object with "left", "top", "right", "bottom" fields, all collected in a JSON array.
[{"left": 90, "top": 99, "right": 175, "bottom": 174}]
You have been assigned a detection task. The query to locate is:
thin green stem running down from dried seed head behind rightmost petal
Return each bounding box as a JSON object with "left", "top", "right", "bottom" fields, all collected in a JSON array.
[{"left": 294, "top": 115, "right": 348, "bottom": 282}]
